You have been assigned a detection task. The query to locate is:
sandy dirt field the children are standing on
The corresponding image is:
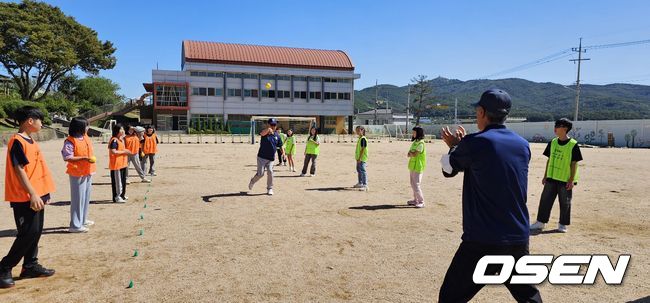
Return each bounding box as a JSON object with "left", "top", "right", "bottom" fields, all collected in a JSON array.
[{"left": 0, "top": 140, "right": 650, "bottom": 302}]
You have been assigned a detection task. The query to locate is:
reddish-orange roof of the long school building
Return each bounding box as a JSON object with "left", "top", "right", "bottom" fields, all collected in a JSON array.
[{"left": 183, "top": 40, "right": 354, "bottom": 71}]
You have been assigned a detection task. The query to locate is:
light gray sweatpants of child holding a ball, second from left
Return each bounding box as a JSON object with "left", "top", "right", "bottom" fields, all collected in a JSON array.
[{"left": 70, "top": 175, "right": 93, "bottom": 229}]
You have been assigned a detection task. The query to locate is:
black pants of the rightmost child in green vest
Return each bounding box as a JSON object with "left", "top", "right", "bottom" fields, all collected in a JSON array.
[{"left": 537, "top": 179, "right": 573, "bottom": 225}]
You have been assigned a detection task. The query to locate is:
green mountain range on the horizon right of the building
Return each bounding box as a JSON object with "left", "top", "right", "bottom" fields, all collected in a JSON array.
[{"left": 355, "top": 77, "right": 650, "bottom": 121}]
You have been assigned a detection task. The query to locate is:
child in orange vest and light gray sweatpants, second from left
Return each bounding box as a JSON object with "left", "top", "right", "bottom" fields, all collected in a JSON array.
[{"left": 61, "top": 117, "right": 96, "bottom": 233}]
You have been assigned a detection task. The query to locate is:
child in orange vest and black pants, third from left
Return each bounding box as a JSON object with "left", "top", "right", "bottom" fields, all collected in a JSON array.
[{"left": 108, "top": 124, "right": 131, "bottom": 203}]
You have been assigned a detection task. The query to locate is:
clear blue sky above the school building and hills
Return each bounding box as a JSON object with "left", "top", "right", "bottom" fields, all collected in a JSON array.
[{"left": 12, "top": 0, "right": 650, "bottom": 97}]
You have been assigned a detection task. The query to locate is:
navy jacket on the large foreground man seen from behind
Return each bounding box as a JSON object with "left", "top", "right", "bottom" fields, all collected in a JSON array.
[{"left": 443, "top": 125, "right": 530, "bottom": 245}]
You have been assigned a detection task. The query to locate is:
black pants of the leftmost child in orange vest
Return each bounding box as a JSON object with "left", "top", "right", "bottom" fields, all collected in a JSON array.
[{"left": 0, "top": 202, "right": 49, "bottom": 270}]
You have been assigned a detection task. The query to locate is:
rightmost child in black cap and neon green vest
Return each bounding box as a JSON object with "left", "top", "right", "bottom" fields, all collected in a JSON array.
[{"left": 530, "top": 118, "right": 582, "bottom": 233}]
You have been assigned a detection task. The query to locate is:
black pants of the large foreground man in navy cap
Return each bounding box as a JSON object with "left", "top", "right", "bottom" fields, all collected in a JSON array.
[{"left": 438, "top": 241, "right": 542, "bottom": 303}]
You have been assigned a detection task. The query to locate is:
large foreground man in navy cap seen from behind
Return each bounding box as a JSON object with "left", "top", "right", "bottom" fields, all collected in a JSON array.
[{"left": 439, "top": 89, "right": 542, "bottom": 302}]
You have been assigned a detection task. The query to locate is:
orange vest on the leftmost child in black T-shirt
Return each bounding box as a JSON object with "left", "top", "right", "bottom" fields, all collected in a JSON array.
[{"left": 5, "top": 134, "right": 55, "bottom": 202}]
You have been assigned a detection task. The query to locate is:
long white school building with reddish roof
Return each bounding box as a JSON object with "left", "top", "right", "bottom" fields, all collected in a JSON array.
[{"left": 143, "top": 40, "right": 360, "bottom": 133}]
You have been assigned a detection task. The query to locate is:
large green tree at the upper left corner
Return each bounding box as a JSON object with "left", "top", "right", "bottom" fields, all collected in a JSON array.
[{"left": 0, "top": 0, "right": 116, "bottom": 100}]
